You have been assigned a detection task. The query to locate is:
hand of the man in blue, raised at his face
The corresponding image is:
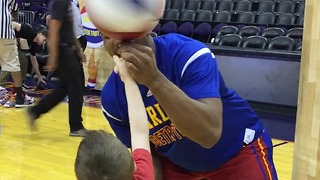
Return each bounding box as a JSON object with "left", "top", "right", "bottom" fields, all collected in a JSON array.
[{"left": 116, "top": 43, "right": 161, "bottom": 87}]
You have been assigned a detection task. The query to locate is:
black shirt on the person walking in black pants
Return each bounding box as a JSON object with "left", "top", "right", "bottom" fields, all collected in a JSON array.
[{"left": 49, "top": 0, "right": 75, "bottom": 44}]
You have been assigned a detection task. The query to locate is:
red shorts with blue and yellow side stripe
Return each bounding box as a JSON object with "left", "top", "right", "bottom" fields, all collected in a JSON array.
[{"left": 161, "top": 132, "right": 278, "bottom": 180}]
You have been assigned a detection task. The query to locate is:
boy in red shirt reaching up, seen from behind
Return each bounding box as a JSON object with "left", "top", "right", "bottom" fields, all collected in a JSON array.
[{"left": 75, "top": 56, "right": 154, "bottom": 180}]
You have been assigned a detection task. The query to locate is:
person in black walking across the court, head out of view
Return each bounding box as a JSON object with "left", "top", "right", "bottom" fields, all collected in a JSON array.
[{"left": 27, "top": 0, "right": 87, "bottom": 136}]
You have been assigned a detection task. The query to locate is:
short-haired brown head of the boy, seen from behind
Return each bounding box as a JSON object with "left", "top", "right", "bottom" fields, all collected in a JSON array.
[{"left": 75, "top": 130, "right": 135, "bottom": 180}]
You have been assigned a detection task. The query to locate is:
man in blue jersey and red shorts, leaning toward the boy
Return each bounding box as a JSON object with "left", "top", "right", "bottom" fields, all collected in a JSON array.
[{"left": 101, "top": 34, "right": 277, "bottom": 180}]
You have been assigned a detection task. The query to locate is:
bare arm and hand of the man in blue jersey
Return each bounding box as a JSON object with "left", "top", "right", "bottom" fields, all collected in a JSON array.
[{"left": 117, "top": 44, "right": 222, "bottom": 148}]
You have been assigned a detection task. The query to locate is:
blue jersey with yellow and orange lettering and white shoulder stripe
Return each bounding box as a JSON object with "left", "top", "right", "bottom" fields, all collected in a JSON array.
[{"left": 101, "top": 34, "right": 264, "bottom": 172}]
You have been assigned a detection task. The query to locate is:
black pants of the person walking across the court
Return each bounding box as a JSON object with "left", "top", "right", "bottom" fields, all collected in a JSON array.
[{"left": 31, "top": 46, "right": 83, "bottom": 131}]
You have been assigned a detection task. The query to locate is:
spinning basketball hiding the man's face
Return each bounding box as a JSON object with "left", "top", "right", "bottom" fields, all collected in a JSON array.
[{"left": 84, "top": 0, "right": 165, "bottom": 40}]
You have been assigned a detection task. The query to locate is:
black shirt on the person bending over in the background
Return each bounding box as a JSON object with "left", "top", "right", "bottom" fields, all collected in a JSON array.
[{"left": 15, "top": 24, "right": 38, "bottom": 56}]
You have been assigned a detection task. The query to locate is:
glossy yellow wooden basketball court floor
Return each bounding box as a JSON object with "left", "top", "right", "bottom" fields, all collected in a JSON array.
[{"left": 0, "top": 103, "right": 293, "bottom": 180}]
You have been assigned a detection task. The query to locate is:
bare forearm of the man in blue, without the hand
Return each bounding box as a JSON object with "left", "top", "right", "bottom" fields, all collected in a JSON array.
[{"left": 147, "top": 74, "right": 222, "bottom": 148}]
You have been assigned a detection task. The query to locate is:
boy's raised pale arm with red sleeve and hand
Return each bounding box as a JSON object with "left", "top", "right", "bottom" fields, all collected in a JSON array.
[{"left": 113, "top": 56, "right": 154, "bottom": 180}]
